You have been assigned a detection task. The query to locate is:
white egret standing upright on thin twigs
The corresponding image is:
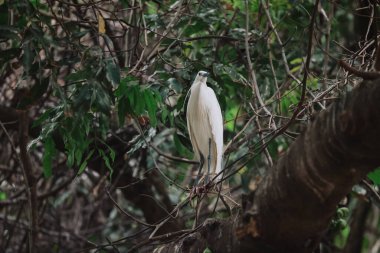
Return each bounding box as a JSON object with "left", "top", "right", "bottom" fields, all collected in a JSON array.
[{"left": 186, "top": 71, "right": 223, "bottom": 181}]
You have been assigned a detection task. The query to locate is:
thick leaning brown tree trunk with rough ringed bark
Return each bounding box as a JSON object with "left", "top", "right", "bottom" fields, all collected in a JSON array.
[{"left": 157, "top": 80, "right": 380, "bottom": 253}]
